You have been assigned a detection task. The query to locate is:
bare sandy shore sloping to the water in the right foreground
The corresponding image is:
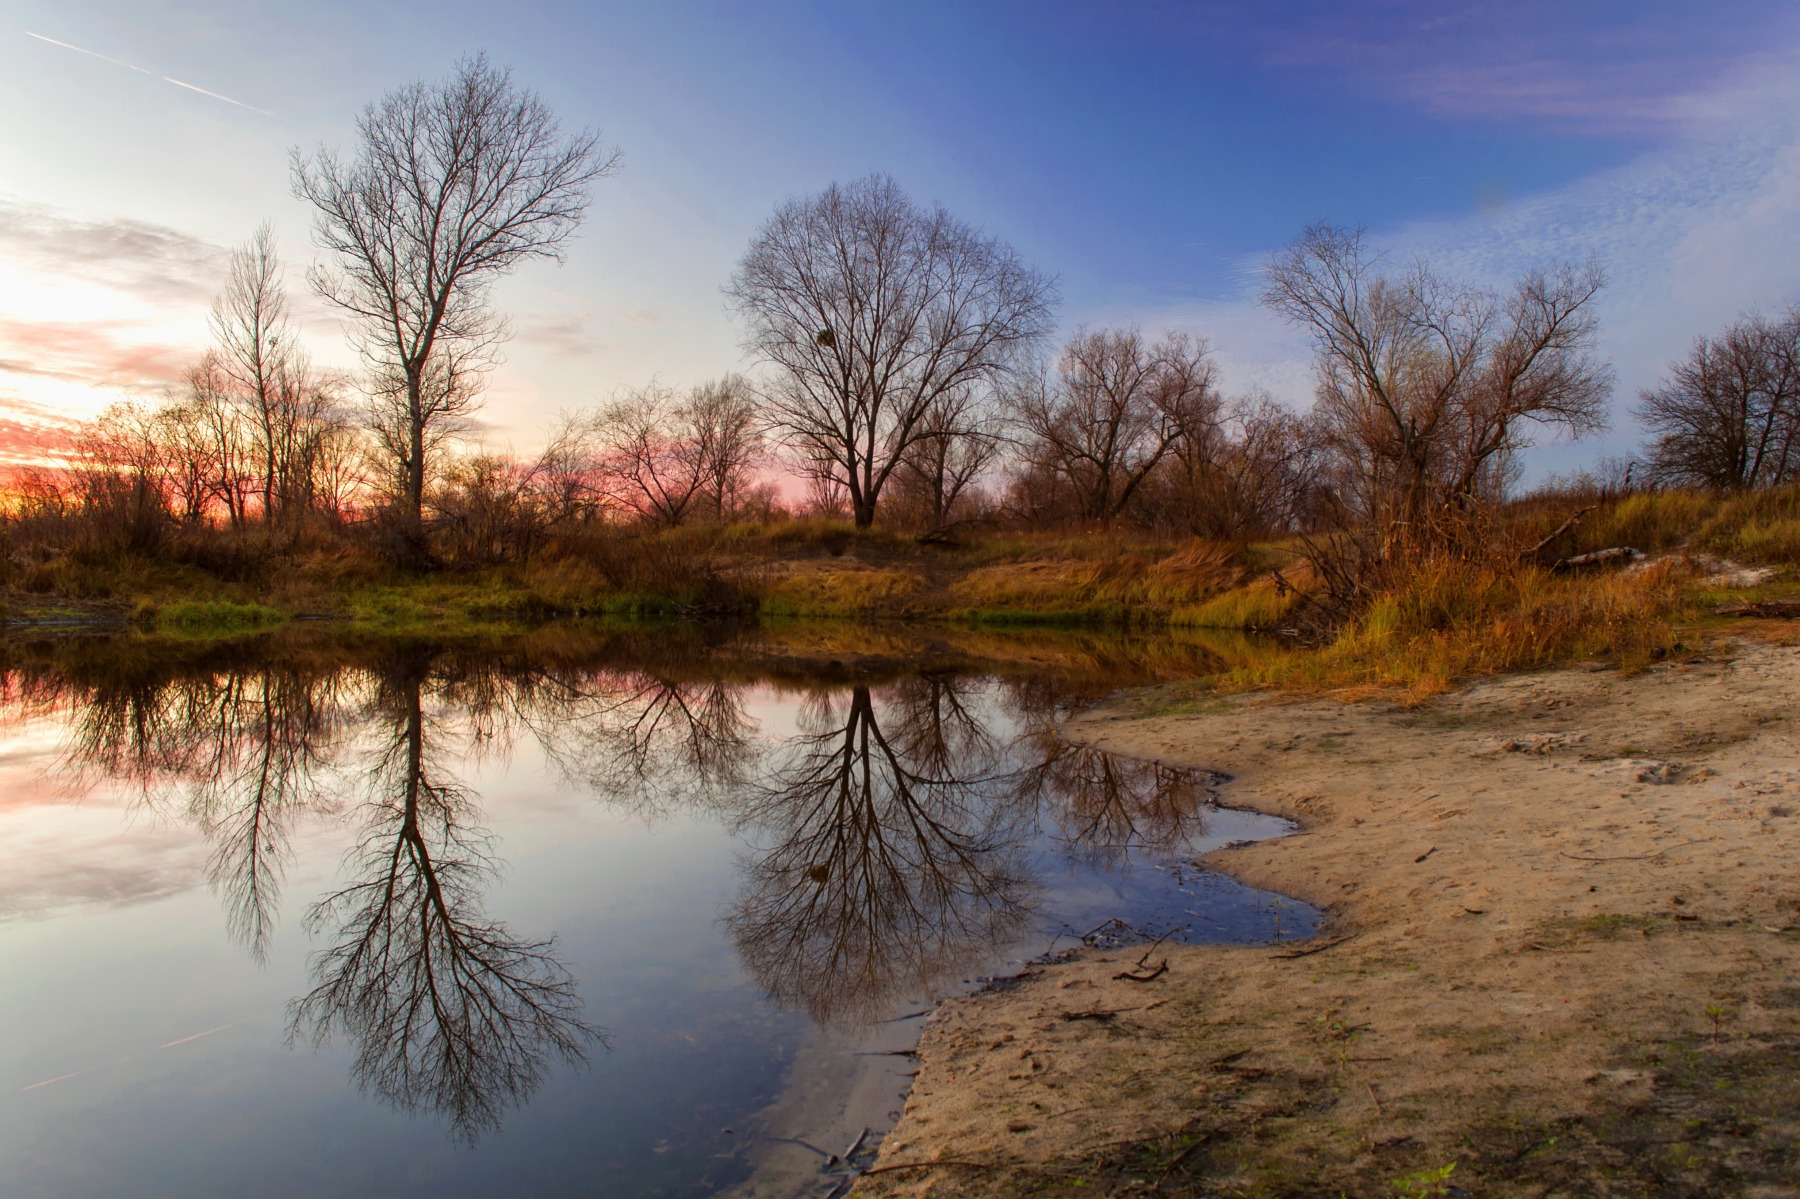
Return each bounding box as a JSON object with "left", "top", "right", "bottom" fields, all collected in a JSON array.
[{"left": 855, "top": 645, "right": 1800, "bottom": 1199}]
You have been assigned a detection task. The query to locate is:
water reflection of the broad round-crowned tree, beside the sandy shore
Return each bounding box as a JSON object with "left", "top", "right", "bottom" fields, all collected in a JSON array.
[{"left": 725, "top": 677, "right": 1035, "bottom": 1021}]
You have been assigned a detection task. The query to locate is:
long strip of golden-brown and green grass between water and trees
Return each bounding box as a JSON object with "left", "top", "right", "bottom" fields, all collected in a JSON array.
[{"left": 0, "top": 488, "right": 1800, "bottom": 699}]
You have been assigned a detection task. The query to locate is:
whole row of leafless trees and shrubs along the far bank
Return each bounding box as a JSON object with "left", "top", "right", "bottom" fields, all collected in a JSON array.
[{"left": 5, "top": 58, "right": 1800, "bottom": 612}]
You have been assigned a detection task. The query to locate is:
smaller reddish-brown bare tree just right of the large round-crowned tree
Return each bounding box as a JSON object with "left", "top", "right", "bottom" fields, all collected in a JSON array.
[{"left": 1010, "top": 329, "right": 1220, "bottom": 526}]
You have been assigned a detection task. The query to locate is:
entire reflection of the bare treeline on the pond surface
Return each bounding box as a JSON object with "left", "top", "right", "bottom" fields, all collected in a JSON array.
[{"left": 21, "top": 646, "right": 1245, "bottom": 1140}]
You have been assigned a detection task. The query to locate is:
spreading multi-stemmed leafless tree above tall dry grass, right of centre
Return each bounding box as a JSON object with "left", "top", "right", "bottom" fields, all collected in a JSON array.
[{"left": 1262, "top": 225, "right": 1613, "bottom": 544}]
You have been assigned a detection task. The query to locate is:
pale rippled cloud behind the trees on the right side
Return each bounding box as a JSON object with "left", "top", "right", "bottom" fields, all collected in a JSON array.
[{"left": 1089, "top": 43, "right": 1800, "bottom": 468}]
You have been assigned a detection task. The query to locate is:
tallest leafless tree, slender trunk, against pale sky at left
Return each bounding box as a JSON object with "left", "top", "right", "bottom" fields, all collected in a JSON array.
[{"left": 292, "top": 54, "right": 617, "bottom": 554}]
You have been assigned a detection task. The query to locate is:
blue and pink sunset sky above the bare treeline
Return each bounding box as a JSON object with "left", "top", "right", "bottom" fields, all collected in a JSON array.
[{"left": 0, "top": 0, "right": 1800, "bottom": 473}]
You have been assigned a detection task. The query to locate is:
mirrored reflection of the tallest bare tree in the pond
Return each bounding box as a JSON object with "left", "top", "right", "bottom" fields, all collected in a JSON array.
[{"left": 288, "top": 670, "right": 599, "bottom": 1141}]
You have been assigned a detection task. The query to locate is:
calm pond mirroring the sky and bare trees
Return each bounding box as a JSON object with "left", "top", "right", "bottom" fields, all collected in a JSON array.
[{"left": 0, "top": 630, "right": 1314, "bottom": 1199}]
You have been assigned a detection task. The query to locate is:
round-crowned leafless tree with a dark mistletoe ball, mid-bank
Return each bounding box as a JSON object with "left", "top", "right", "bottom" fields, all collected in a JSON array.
[{"left": 725, "top": 175, "right": 1055, "bottom": 527}]
